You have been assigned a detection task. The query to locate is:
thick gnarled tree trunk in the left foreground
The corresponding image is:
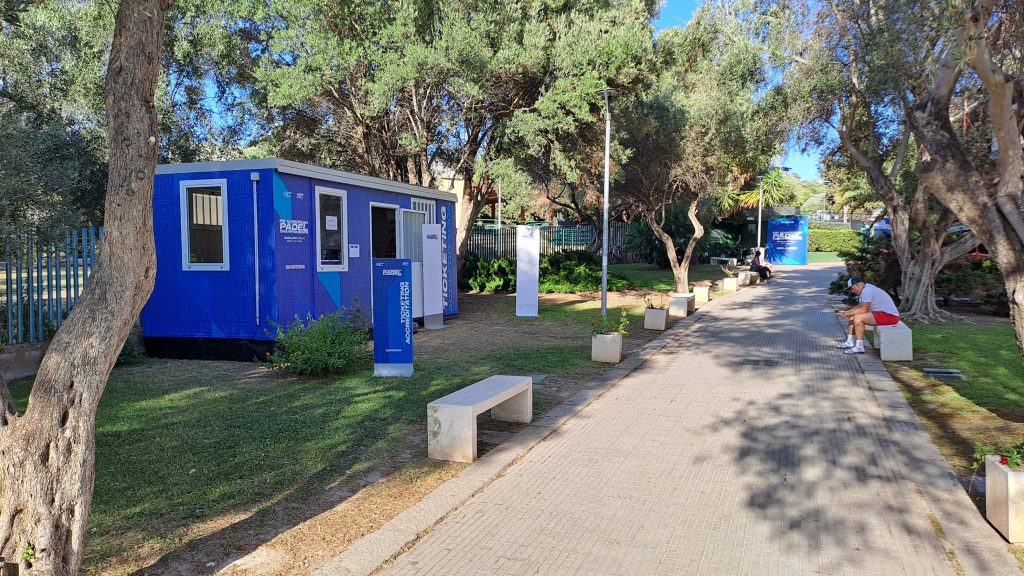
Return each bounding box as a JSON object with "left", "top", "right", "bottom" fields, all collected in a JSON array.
[{"left": 0, "top": 0, "right": 170, "bottom": 576}]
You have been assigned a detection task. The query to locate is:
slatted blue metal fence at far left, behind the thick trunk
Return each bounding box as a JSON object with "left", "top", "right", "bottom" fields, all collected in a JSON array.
[{"left": 0, "top": 227, "right": 103, "bottom": 344}]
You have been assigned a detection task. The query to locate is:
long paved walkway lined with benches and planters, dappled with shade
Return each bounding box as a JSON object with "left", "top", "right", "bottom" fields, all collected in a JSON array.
[{"left": 386, "top": 268, "right": 954, "bottom": 576}]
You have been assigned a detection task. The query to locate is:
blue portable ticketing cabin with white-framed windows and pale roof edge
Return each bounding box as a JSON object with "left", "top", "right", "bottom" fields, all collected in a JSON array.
[{"left": 141, "top": 158, "right": 459, "bottom": 360}]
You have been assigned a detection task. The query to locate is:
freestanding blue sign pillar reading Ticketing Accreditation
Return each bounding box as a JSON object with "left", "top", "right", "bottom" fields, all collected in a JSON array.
[{"left": 373, "top": 258, "right": 413, "bottom": 376}]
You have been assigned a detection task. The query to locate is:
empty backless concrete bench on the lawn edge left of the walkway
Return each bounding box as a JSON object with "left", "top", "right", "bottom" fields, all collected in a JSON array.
[{"left": 427, "top": 376, "right": 534, "bottom": 462}]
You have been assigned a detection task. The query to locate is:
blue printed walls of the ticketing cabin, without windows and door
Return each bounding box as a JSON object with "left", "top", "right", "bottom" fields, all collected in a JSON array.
[{"left": 142, "top": 162, "right": 458, "bottom": 339}]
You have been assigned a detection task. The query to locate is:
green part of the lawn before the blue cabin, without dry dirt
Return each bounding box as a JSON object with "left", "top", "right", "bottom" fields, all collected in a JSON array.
[{"left": 12, "top": 345, "right": 590, "bottom": 574}]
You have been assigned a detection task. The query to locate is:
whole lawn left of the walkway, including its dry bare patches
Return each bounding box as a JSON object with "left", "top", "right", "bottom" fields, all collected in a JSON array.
[{"left": 4, "top": 292, "right": 675, "bottom": 576}]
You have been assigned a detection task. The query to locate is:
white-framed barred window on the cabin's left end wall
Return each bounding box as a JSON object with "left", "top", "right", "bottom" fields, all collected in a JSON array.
[{"left": 180, "top": 179, "right": 229, "bottom": 271}]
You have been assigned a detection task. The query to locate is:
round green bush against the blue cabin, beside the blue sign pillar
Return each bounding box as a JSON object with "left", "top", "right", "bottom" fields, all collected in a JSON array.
[{"left": 266, "top": 307, "right": 373, "bottom": 375}]
